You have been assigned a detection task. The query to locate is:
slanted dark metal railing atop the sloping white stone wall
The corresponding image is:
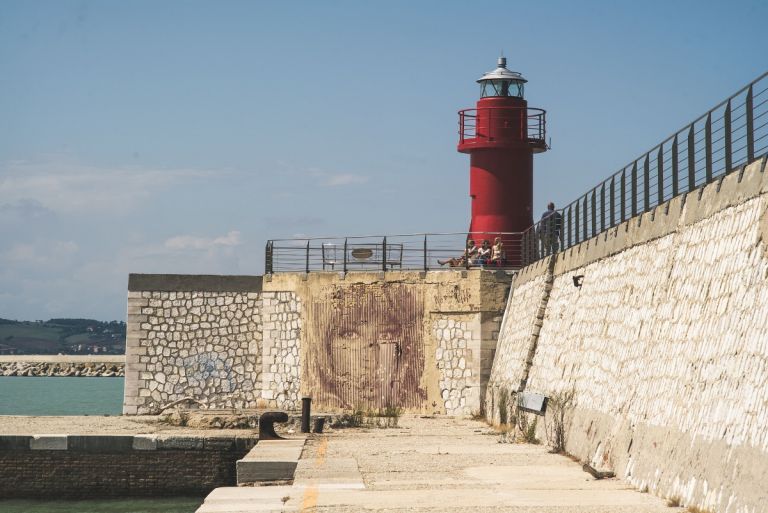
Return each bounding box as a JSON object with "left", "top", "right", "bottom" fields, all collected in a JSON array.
[{"left": 522, "top": 72, "right": 768, "bottom": 259}]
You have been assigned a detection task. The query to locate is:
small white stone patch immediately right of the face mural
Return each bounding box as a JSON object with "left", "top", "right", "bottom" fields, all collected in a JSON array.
[{"left": 433, "top": 313, "right": 481, "bottom": 415}]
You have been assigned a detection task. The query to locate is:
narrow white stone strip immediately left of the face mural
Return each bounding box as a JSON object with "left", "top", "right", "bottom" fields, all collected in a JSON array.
[{"left": 261, "top": 292, "right": 301, "bottom": 410}]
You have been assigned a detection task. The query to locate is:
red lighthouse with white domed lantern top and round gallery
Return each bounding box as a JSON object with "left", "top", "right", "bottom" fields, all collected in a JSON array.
[{"left": 458, "top": 57, "right": 547, "bottom": 265}]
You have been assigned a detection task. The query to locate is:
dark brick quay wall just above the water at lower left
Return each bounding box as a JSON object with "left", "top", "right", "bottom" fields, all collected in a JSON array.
[{"left": 0, "top": 435, "right": 256, "bottom": 499}]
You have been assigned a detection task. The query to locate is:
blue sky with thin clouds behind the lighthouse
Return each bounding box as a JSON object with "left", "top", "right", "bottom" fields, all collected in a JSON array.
[{"left": 0, "top": 0, "right": 768, "bottom": 319}]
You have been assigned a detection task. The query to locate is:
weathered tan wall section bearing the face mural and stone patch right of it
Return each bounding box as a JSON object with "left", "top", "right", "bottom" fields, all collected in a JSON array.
[{"left": 263, "top": 270, "right": 511, "bottom": 415}]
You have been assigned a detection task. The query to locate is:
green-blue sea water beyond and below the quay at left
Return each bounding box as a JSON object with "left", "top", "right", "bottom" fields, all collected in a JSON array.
[{"left": 0, "top": 376, "right": 203, "bottom": 513}]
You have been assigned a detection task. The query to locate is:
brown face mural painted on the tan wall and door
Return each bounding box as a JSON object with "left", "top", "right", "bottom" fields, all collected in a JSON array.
[{"left": 302, "top": 283, "right": 427, "bottom": 409}]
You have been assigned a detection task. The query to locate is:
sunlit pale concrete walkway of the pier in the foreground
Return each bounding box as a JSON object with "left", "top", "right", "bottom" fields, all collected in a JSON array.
[{"left": 197, "top": 417, "right": 682, "bottom": 513}]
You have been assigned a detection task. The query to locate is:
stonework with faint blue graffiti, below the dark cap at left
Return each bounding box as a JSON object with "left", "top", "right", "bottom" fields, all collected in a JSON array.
[{"left": 124, "top": 291, "right": 261, "bottom": 414}]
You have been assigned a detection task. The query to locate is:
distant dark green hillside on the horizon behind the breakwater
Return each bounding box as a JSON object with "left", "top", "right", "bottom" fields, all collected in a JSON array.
[{"left": 0, "top": 318, "right": 125, "bottom": 354}]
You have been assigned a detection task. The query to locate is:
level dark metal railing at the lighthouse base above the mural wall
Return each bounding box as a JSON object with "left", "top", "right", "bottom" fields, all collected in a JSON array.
[{"left": 264, "top": 232, "right": 530, "bottom": 274}]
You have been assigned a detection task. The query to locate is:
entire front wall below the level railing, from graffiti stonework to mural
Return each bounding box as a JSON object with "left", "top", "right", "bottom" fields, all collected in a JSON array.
[{"left": 123, "top": 270, "right": 511, "bottom": 415}]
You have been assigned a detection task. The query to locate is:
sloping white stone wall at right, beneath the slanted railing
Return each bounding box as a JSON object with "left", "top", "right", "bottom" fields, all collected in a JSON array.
[{"left": 488, "top": 160, "right": 768, "bottom": 513}]
